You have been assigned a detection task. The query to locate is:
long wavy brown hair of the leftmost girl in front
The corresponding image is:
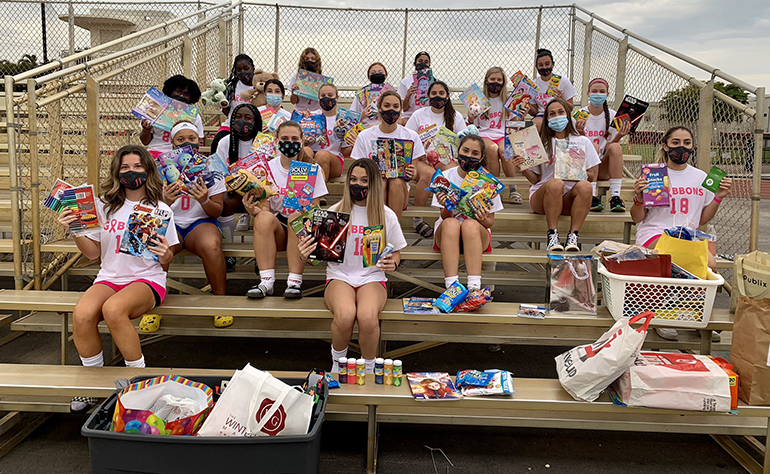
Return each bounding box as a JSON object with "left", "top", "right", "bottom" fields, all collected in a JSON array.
[{"left": 101, "top": 145, "right": 163, "bottom": 218}]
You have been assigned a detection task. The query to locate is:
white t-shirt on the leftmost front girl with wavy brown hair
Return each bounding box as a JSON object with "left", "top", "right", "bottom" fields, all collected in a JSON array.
[{"left": 88, "top": 199, "right": 179, "bottom": 288}]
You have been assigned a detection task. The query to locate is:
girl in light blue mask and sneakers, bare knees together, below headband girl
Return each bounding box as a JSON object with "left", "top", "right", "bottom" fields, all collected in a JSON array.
[{"left": 513, "top": 99, "right": 601, "bottom": 252}]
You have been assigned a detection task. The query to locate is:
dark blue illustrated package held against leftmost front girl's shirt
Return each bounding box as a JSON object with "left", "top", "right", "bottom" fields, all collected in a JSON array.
[{"left": 119, "top": 204, "right": 171, "bottom": 262}]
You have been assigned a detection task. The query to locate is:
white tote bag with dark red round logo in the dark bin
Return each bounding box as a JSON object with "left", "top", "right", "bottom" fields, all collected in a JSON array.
[{"left": 198, "top": 364, "right": 313, "bottom": 436}]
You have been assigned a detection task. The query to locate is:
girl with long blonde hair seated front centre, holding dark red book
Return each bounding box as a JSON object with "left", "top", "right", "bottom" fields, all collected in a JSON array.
[{"left": 300, "top": 158, "right": 406, "bottom": 374}]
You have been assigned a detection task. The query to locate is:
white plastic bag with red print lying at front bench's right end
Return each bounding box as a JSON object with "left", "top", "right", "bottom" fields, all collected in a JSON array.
[{"left": 614, "top": 352, "right": 731, "bottom": 412}]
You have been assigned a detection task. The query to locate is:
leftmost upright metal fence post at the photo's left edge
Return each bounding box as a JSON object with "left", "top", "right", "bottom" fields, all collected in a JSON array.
[{"left": 5, "top": 75, "right": 24, "bottom": 290}]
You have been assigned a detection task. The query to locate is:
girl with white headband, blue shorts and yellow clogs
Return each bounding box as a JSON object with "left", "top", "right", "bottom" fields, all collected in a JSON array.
[{"left": 163, "top": 122, "right": 228, "bottom": 327}]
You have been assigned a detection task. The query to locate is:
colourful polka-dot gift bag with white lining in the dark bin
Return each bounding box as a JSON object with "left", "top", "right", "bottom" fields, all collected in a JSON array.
[{"left": 111, "top": 375, "right": 214, "bottom": 435}]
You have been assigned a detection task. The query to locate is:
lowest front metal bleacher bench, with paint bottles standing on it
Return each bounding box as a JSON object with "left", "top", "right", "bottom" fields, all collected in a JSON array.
[{"left": 0, "top": 364, "right": 770, "bottom": 474}]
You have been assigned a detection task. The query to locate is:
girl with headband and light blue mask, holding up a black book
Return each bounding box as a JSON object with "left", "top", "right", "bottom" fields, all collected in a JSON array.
[{"left": 575, "top": 78, "right": 631, "bottom": 212}]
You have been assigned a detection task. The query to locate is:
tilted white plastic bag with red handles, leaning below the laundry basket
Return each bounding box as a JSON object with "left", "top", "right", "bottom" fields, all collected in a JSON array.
[{"left": 556, "top": 311, "right": 655, "bottom": 402}]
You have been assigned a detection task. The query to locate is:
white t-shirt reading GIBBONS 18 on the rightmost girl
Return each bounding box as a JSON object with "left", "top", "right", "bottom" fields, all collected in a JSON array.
[{"left": 636, "top": 165, "right": 714, "bottom": 245}]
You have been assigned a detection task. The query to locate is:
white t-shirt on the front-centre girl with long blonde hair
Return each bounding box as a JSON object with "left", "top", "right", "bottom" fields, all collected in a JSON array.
[{"left": 326, "top": 205, "right": 406, "bottom": 288}]
